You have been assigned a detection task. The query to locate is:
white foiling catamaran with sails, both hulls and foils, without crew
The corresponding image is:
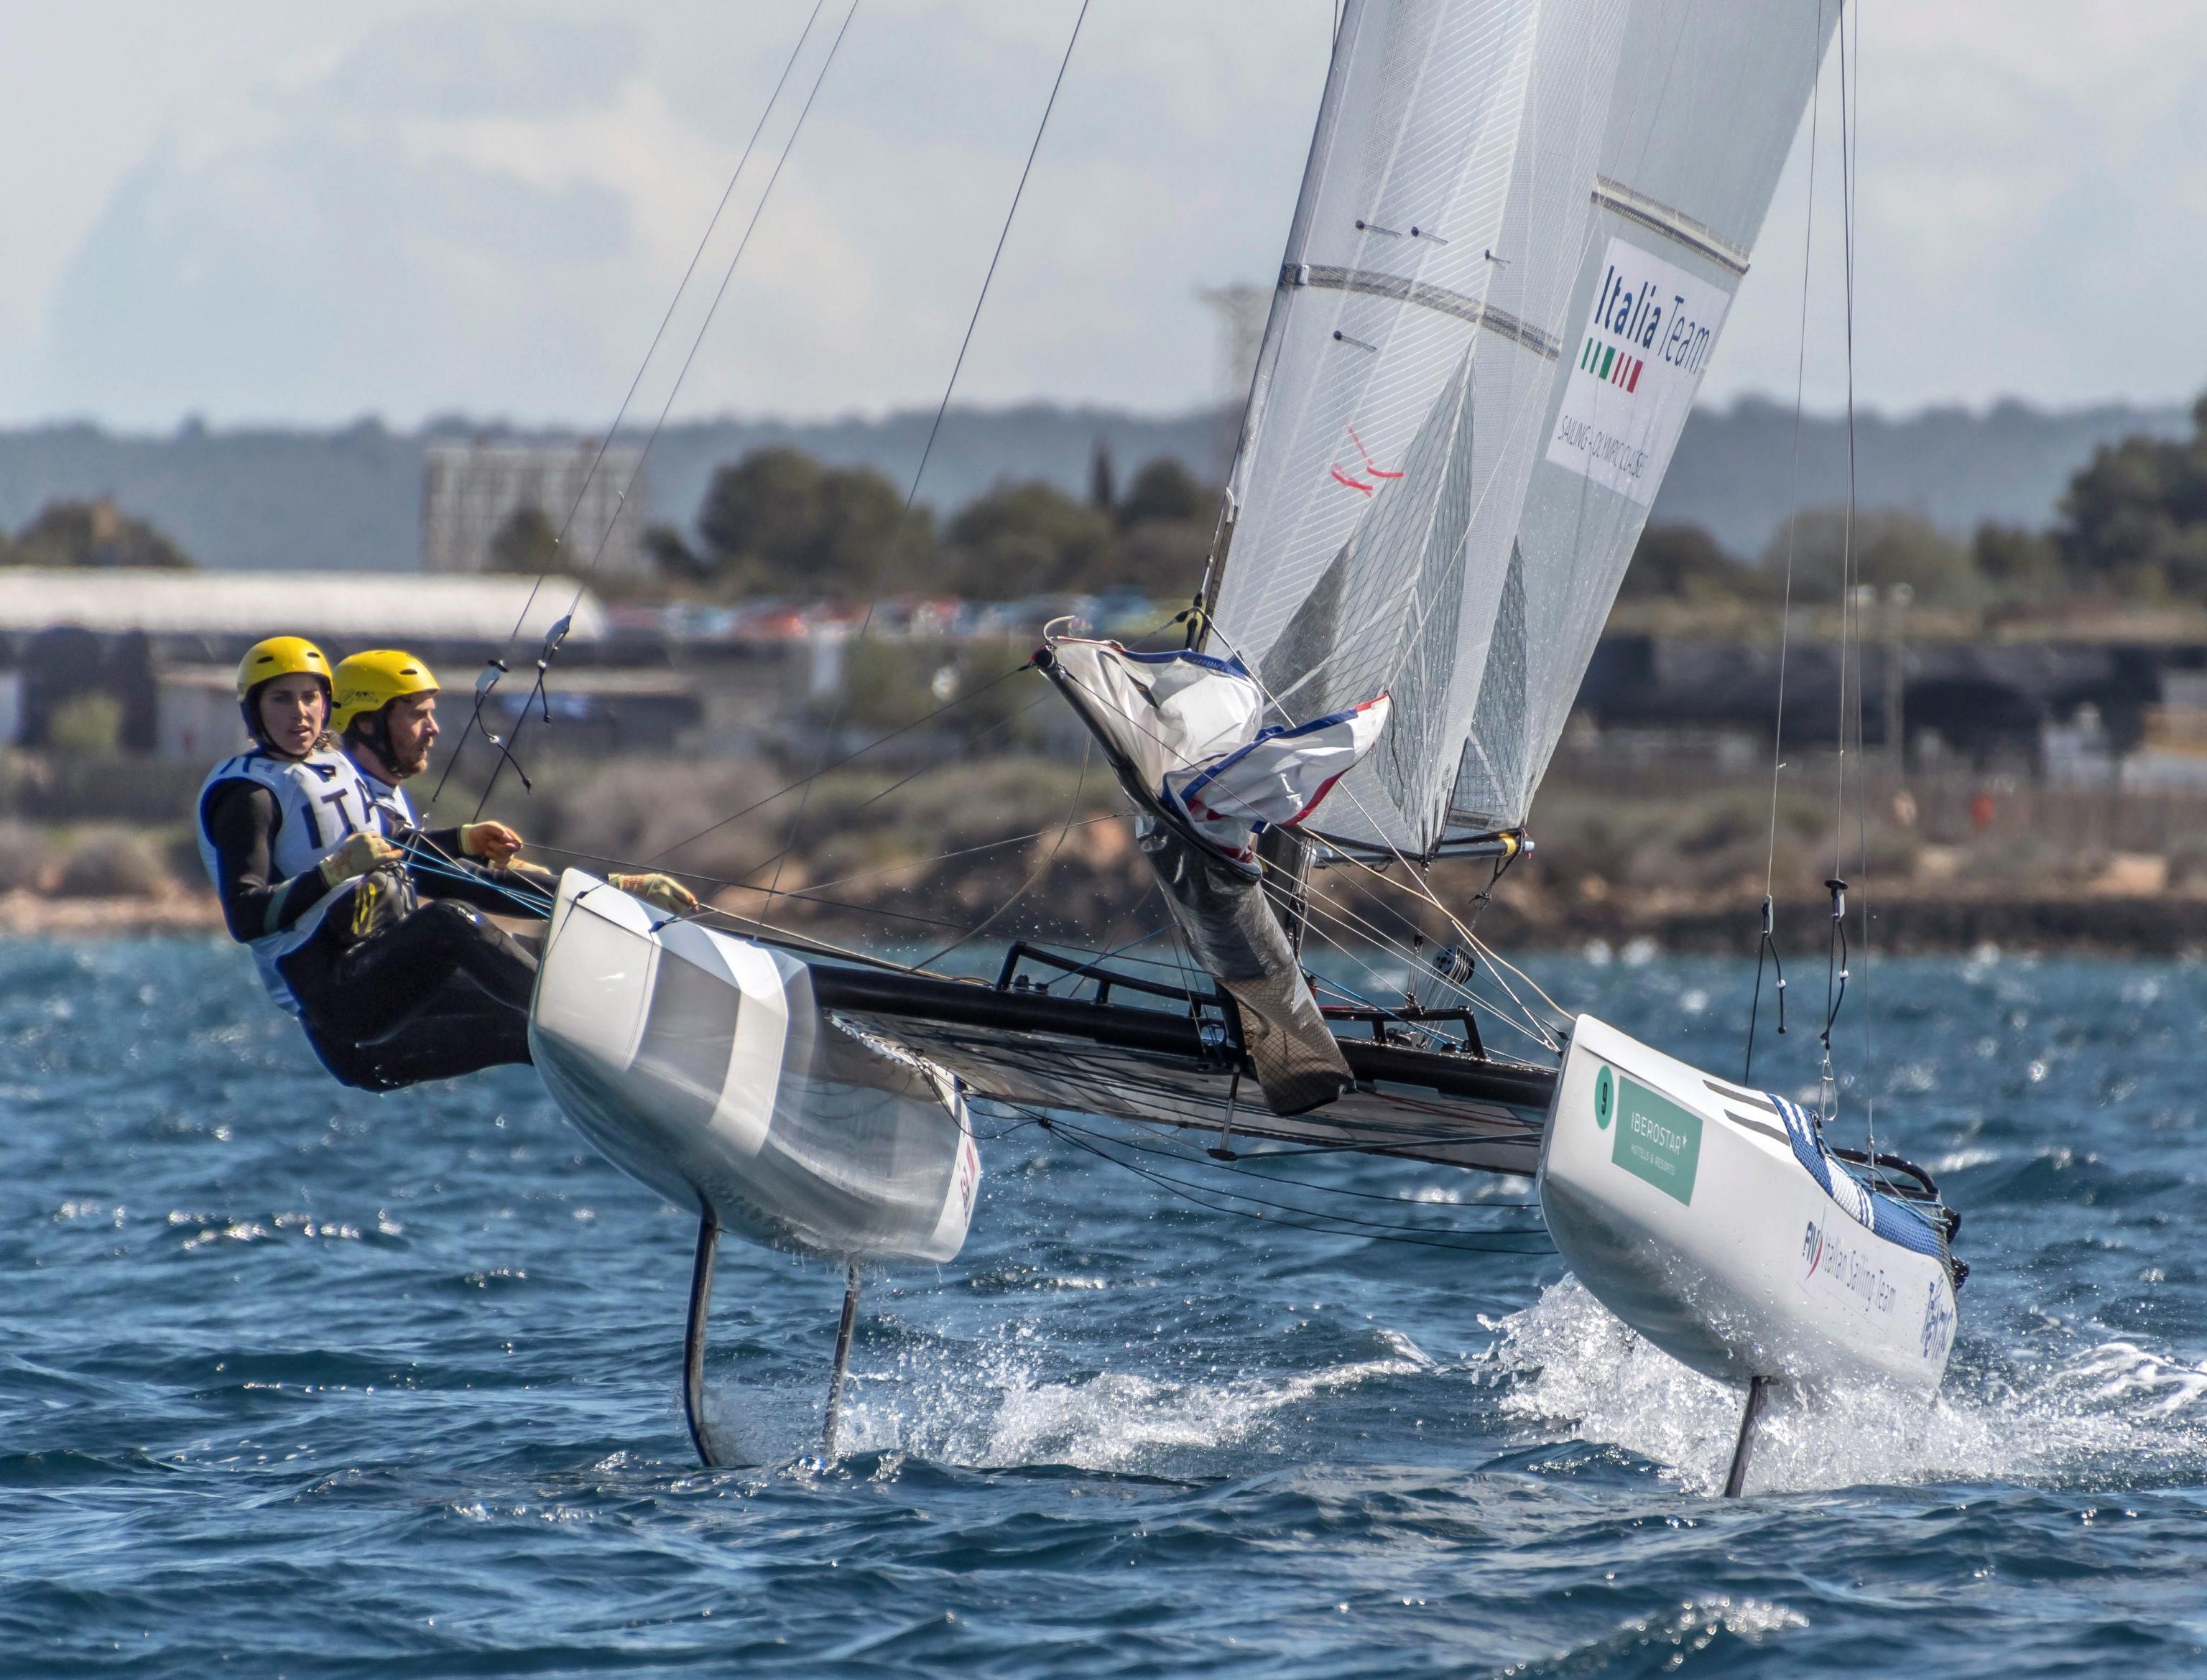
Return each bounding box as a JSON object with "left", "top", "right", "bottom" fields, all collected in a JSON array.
[{"left": 505, "top": 0, "right": 1962, "bottom": 1493}]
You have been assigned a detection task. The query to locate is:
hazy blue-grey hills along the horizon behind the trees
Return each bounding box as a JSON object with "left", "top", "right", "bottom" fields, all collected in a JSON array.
[{"left": 0, "top": 399, "right": 2187, "bottom": 570}]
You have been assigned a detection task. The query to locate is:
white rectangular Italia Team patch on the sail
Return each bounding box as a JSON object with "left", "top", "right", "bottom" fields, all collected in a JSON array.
[{"left": 1547, "top": 238, "right": 1733, "bottom": 508}]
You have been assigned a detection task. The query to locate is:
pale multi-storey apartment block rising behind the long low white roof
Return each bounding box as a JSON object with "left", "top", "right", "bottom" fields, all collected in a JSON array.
[{"left": 422, "top": 440, "right": 644, "bottom": 578}]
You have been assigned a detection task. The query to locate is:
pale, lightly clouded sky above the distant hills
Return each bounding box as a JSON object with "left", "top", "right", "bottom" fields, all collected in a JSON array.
[{"left": 0, "top": 0, "right": 2207, "bottom": 430}]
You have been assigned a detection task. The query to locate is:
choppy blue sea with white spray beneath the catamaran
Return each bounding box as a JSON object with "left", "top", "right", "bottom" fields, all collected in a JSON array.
[{"left": 0, "top": 940, "right": 2207, "bottom": 1680}]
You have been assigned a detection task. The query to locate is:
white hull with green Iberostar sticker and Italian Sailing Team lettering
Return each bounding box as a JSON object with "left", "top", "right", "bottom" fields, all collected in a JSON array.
[{"left": 1540, "top": 1016, "right": 1956, "bottom": 1391}]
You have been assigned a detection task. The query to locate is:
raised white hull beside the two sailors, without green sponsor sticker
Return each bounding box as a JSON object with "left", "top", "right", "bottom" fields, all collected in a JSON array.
[{"left": 529, "top": 870, "right": 980, "bottom": 1261}]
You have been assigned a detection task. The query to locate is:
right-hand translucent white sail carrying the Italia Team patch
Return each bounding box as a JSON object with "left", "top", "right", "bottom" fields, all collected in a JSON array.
[{"left": 1450, "top": 0, "right": 1838, "bottom": 830}]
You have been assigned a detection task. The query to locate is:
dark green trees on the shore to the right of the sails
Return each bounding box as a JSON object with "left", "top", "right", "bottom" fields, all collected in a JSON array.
[{"left": 1620, "top": 397, "right": 2207, "bottom": 611}]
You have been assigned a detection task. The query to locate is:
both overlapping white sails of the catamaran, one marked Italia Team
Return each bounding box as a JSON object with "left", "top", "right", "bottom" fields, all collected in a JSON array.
[{"left": 1209, "top": 0, "right": 1838, "bottom": 857}]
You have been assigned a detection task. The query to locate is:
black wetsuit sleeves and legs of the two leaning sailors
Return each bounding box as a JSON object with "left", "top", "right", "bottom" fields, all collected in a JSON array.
[{"left": 208, "top": 781, "right": 545, "bottom": 1090}]
